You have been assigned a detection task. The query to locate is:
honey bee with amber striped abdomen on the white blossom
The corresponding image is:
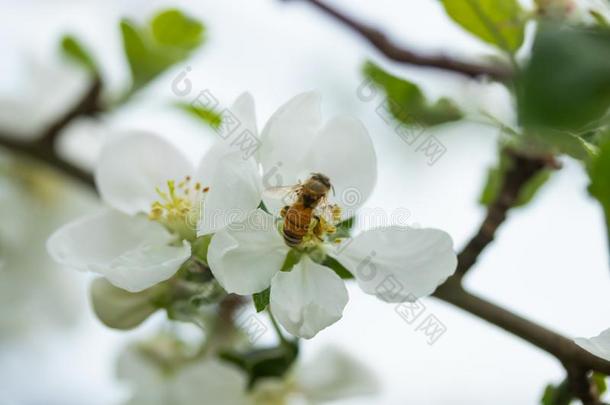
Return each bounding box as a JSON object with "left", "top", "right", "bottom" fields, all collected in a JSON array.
[{"left": 265, "top": 173, "right": 336, "bottom": 247}]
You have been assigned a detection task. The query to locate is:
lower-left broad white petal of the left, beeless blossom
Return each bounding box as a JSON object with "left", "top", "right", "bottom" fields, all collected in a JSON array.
[{"left": 47, "top": 210, "right": 191, "bottom": 292}]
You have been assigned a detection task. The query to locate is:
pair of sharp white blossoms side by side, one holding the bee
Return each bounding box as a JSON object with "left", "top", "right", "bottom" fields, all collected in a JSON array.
[{"left": 48, "top": 92, "right": 457, "bottom": 338}]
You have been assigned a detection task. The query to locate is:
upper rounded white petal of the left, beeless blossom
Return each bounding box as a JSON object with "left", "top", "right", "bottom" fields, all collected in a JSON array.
[{"left": 95, "top": 132, "right": 193, "bottom": 215}]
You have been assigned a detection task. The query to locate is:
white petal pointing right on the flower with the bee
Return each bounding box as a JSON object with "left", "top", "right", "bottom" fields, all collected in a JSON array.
[{"left": 329, "top": 226, "right": 457, "bottom": 302}]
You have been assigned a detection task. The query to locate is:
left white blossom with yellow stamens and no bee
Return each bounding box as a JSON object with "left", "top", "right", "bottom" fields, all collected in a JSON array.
[{"left": 47, "top": 94, "right": 261, "bottom": 292}]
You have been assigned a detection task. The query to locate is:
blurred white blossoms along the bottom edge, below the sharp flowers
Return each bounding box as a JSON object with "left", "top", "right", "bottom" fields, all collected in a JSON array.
[{"left": 117, "top": 336, "right": 379, "bottom": 405}]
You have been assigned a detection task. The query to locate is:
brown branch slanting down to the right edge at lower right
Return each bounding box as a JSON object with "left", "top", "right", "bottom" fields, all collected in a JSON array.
[{"left": 433, "top": 278, "right": 610, "bottom": 375}]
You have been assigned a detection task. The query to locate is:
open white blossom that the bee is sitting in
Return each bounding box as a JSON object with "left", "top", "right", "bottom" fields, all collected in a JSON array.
[{"left": 208, "top": 93, "right": 457, "bottom": 338}]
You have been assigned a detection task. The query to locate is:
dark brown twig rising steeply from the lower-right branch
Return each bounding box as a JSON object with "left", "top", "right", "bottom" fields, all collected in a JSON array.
[{"left": 456, "top": 150, "right": 556, "bottom": 277}]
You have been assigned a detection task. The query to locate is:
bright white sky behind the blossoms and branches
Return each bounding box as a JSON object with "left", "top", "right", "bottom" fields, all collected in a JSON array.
[{"left": 0, "top": 0, "right": 610, "bottom": 405}]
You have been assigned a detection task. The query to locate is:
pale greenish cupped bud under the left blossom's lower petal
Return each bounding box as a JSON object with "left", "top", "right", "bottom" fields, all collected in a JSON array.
[{"left": 91, "top": 278, "right": 165, "bottom": 330}]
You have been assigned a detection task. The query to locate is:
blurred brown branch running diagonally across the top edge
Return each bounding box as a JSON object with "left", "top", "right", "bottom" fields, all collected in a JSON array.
[{"left": 284, "top": 0, "right": 513, "bottom": 81}]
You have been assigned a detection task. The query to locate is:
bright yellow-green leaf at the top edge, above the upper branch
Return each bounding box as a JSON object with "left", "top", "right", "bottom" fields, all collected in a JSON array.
[{"left": 441, "top": 0, "right": 526, "bottom": 53}]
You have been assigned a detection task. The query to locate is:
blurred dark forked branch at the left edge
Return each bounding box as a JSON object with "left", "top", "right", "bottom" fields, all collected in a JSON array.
[{"left": 0, "top": 78, "right": 102, "bottom": 189}]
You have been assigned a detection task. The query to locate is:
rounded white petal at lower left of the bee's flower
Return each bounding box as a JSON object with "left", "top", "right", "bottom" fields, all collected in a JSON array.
[{"left": 208, "top": 209, "right": 288, "bottom": 295}]
